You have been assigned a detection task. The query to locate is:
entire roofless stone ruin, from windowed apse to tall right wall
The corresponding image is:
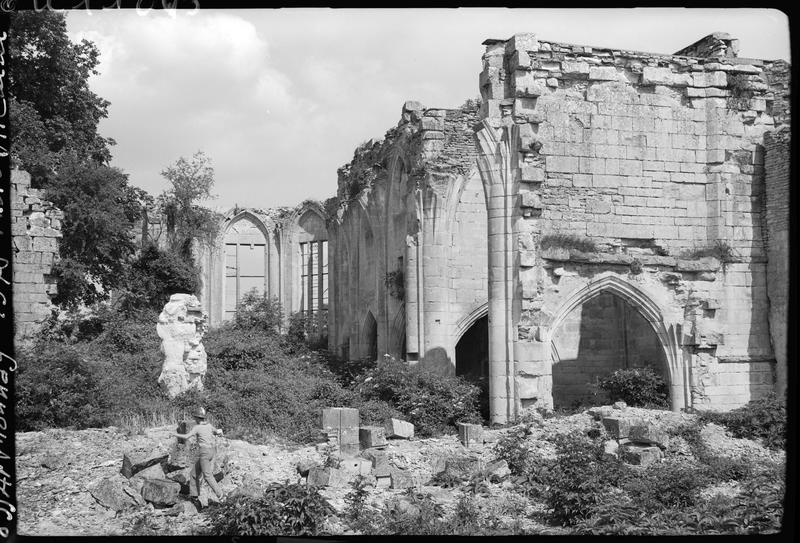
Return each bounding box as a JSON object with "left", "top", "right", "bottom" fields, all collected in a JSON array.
[{"left": 10, "top": 34, "right": 790, "bottom": 423}]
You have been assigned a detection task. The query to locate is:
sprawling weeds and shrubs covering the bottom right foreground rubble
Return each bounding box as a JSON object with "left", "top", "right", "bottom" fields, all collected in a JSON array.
[{"left": 494, "top": 419, "right": 785, "bottom": 535}]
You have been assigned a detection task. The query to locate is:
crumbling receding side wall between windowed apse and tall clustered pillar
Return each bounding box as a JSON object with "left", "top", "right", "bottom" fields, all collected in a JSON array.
[{"left": 329, "top": 102, "right": 487, "bottom": 373}]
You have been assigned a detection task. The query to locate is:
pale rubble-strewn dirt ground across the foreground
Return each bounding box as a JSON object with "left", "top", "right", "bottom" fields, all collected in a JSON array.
[{"left": 16, "top": 408, "right": 784, "bottom": 536}]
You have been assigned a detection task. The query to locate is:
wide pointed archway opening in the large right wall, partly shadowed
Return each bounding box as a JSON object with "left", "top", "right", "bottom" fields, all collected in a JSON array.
[{"left": 551, "top": 291, "right": 669, "bottom": 408}]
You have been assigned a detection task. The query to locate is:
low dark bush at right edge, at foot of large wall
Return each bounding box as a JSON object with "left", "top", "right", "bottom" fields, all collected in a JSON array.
[{"left": 698, "top": 393, "right": 786, "bottom": 450}]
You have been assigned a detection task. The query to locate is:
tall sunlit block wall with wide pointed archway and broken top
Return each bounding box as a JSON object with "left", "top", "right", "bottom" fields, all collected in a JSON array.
[{"left": 478, "top": 34, "right": 782, "bottom": 416}]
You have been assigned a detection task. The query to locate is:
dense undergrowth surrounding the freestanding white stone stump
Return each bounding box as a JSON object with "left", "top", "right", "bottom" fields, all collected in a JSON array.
[{"left": 17, "top": 293, "right": 480, "bottom": 443}]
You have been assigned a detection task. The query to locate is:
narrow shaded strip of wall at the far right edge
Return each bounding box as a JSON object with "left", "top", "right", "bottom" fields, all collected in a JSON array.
[{"left": 764, "top": 127, "right": 791, "bottom": 393}]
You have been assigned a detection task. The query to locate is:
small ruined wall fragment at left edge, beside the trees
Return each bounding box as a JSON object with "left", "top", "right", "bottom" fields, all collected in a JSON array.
[{"left": 11, "top": 170, "right": 64, "bottom": 341}]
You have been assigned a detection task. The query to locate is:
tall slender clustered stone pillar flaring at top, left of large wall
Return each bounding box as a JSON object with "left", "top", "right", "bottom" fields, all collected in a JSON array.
[{"left": 475, "top": 120, "right": 519, "bottom": 424}]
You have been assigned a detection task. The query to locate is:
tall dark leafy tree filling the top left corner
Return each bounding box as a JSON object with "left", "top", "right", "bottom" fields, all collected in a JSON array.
[{"left": 7, "top": 10, "right": 114, "bottom": 186}]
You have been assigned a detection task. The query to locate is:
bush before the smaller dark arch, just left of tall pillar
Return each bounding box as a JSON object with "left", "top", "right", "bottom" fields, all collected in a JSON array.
[{"left": 354, "top": 358, "right": 481, "bottom": 437}]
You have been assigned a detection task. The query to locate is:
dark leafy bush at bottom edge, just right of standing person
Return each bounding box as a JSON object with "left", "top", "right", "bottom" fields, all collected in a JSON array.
[{"left": 208, "top": 483, "right": 334, "bottom": 536}]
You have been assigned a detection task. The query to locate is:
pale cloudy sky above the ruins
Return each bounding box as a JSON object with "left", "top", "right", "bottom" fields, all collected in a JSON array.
[{"left": 67, "top": 9, "right": 791, "bottom": 210}]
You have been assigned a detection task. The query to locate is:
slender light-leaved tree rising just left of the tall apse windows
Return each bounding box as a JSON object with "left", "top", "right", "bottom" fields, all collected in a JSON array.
[{"left": 158, "top": 151, "right": 219, "bottom": 260}]
